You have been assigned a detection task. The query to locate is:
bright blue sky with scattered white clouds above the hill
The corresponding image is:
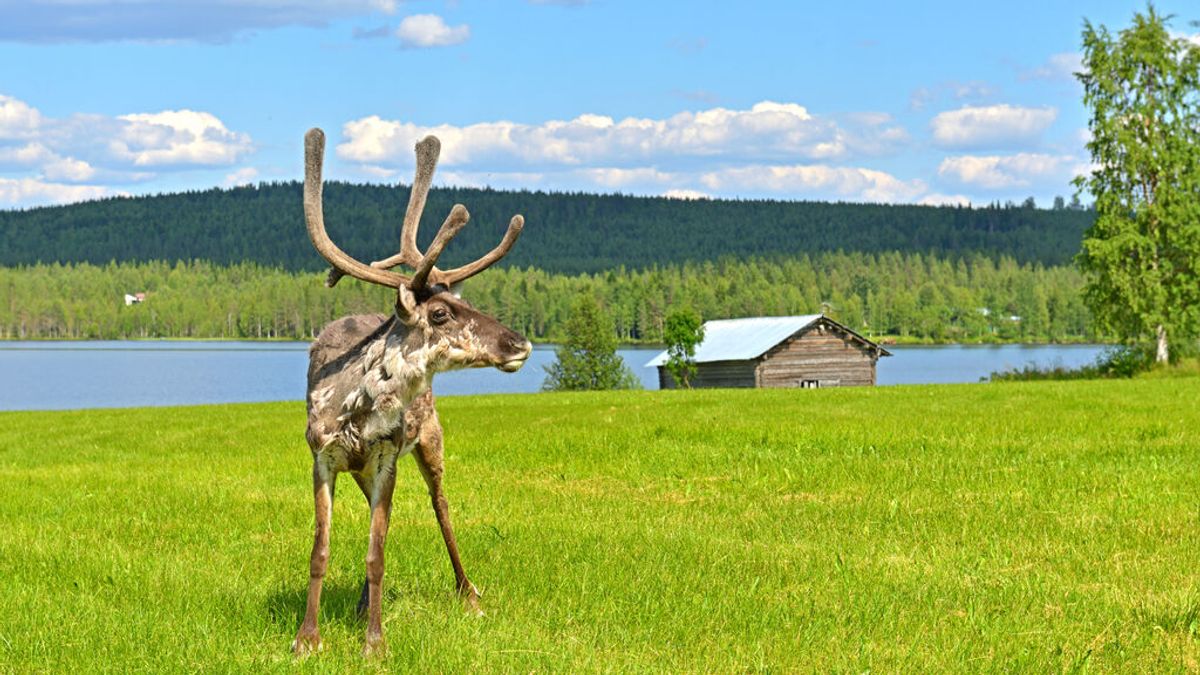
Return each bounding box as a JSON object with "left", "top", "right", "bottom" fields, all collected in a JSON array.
[{"left": 0, "top": 0, "right": 1200, "bottom": 208}]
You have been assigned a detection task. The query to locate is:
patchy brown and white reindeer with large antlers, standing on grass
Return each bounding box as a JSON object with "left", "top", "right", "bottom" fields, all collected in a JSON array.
[{"left": 292, "top": 129, "right": 533, "bottom": 655}]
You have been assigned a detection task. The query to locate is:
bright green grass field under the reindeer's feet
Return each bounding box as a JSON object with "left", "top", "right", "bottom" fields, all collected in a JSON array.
[{"left": 0, "top": 378, "right": 1200, "bottom": 673}]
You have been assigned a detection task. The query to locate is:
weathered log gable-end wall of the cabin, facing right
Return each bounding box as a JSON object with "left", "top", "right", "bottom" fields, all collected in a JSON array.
[{"left": 756, "top": 323, "right": 877, "bottom": 387}]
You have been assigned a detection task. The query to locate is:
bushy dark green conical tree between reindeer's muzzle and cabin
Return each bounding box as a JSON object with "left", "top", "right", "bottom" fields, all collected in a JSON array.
[{"left": 542, "top": 294, "right": 640, "bottom": 392}]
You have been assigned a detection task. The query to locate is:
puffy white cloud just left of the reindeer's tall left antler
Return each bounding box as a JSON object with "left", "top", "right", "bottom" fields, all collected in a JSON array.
[{"left": 109, "top": 110, "right": 251, "bottom": 167}]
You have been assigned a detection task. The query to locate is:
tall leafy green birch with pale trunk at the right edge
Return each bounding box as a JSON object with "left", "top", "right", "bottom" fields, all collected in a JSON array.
[{"left": 1076, "top": 6, "right": 1200, "bottom": 362}]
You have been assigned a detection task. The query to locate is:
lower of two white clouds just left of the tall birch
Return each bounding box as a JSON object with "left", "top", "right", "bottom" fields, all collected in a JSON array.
[{"left": 937, "top": 153, "right": 1084, "bottom": 190}]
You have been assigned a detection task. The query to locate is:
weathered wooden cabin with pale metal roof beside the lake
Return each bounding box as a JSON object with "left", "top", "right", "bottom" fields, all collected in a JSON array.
[{"left": 646, "top": 315, "right": 892, "bottom": 389}]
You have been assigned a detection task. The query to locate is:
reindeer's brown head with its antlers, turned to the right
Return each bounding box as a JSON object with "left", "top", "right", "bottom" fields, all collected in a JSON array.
[{"left": 304, "top": 129, "right": 533, "bottom": 375}]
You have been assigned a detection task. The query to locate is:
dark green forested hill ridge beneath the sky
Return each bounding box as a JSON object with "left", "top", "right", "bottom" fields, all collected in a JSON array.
[{"left": 0, "top": 183, "right": 1092, "bottom": 274}]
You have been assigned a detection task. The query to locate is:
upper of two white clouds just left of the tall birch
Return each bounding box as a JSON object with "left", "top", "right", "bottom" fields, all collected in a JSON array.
[{"left": 930, "top": 103, "right": 1058, "bottom": 149}]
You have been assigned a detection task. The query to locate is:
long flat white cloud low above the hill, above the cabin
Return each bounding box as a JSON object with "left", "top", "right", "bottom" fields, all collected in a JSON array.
[{"left": 700, "top": 165, "right": 926, "bottom": 202}]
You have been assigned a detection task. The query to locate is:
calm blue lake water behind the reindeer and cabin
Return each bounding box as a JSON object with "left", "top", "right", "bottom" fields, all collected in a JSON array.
[{"left": 0, "top": 341, "right": 1104, "bottom": 410}]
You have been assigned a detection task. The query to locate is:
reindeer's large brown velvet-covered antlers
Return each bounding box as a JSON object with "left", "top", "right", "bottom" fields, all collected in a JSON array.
[{"left": 304, "top": 129, "right": 524, "bottom": 291}]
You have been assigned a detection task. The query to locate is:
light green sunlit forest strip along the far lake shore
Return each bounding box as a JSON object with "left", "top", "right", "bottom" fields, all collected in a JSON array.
[{"left": 0, "top": 251, "right": 1103, "bottom": 342}]
